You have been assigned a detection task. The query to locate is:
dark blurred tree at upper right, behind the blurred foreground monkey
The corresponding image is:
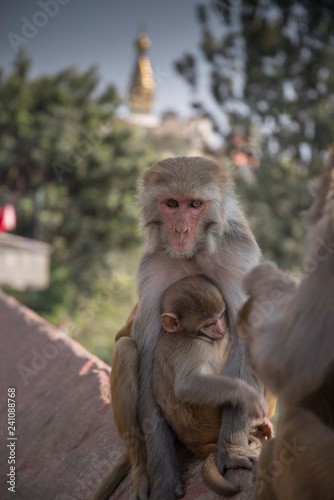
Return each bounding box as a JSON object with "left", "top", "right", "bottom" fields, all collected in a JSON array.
[{"left": 175, "top": 0, "right": 334, "bottom": 268}]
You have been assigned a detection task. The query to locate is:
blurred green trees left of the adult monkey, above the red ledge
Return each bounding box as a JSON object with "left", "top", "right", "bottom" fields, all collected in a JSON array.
[{"left": 0, "top": 53, "right": 156, "bottom": 357}]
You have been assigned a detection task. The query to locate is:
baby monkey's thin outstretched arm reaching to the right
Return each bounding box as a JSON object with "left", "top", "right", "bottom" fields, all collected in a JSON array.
[{"left": 175, "top": 366, "right": 268, "bottom": 418}]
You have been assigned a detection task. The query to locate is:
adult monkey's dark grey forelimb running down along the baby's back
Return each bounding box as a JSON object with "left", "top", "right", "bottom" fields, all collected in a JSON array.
[{"left": 138, "top": 349, "right": 185, "bottom": 500}]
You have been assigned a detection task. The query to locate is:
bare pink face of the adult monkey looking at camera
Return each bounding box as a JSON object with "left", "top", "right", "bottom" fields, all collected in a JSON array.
[{"left": 158, "top": 196, "right": 210, "bottom": 254}]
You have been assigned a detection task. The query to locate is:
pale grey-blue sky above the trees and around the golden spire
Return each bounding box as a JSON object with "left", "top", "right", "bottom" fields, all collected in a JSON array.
[{"left": 0, "top": 0, "right": 220, "bottom": 116}]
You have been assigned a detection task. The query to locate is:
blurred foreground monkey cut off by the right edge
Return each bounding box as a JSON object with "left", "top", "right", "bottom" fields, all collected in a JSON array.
[{"left": 238, "top": 152, "right": 334, "bottom": 500}]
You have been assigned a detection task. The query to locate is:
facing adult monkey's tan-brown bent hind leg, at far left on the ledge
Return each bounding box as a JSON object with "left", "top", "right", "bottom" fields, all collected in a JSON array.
[{"left": 110, "top": 337, "right": 148, "bottom": 500}]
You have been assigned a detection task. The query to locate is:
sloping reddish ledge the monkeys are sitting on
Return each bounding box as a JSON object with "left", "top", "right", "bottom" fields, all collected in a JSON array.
[{"left": 0, "top": 292, "right": 253, "bottom": 500}]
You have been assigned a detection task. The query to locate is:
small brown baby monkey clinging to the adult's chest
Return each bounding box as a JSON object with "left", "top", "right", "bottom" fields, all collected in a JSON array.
[{"left": 153, "top": 276, "right": 272, "bottom": 496}]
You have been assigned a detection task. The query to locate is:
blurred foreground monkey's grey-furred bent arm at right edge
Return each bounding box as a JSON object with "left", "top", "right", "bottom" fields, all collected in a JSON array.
[{"left": 238, "top": 257, "right": 334, "bottom": 403}]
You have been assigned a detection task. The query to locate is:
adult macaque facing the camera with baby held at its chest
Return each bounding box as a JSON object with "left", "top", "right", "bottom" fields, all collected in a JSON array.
[{"left": 92, "top": 157, "right": 260, "bottom": 500}]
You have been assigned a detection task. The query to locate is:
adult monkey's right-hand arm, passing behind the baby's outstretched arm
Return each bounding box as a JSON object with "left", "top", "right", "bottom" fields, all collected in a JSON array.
[{"left": 211, "top": 238, "right": 266, "bottom": 473}]
